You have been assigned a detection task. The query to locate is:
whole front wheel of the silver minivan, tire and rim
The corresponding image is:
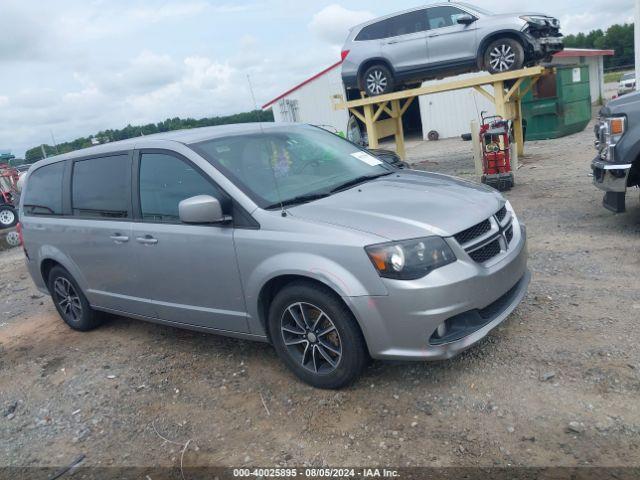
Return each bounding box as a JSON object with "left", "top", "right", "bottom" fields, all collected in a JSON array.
[{"left": 269, "top": 281, "right": 369, "bottom": 389}]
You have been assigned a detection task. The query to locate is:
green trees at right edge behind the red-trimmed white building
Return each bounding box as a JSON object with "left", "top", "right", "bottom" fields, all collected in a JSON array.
[{"left": 564, "top": 23, "right": 635, "bottom": 70}]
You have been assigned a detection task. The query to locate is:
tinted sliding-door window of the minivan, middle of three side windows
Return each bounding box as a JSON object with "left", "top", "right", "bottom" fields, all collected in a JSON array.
[{"left": 71, "top": 154, "right": 131, "bottom": 218}]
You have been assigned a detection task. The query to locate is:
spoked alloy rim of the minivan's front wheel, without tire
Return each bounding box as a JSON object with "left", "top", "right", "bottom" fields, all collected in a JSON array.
[{"left": 280, "top": 302, "right": 342, "bottom": 374}]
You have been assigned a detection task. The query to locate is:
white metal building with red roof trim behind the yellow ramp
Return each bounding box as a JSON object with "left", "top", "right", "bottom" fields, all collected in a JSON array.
[{"left": 262, "top": 48, "right": 614, "bottom": 138}]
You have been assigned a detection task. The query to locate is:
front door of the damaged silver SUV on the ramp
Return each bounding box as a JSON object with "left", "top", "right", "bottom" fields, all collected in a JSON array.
[{"left": 427, "top": 6, "right": 477, "bottom": 66}]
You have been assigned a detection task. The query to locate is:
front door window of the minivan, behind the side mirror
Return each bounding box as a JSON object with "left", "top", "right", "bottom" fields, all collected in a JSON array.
[{"left": 140, "top": 153, "right": 224, "bottom": 223}]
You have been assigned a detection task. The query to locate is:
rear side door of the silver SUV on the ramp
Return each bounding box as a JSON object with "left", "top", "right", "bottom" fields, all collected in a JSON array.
[{"left": 382, "top": 9, "right": 428, "bottom": 74}]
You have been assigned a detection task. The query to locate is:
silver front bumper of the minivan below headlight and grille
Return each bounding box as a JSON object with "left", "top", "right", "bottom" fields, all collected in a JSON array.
[{"left": 349, "top": 224, "right": 531, "bottom": 360}]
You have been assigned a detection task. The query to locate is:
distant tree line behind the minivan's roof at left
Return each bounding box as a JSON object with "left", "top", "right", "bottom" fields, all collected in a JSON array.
[{"left": 25, "top": 110, "right": 273, "bottom": 163}]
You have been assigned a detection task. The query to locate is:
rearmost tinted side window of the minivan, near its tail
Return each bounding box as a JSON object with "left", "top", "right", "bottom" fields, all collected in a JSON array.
[{"left": 24, "top": 162, "right": 64, "bottom": 215}]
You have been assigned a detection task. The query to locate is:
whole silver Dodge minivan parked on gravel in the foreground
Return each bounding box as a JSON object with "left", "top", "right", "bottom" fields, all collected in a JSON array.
[{"left": 20, "top": 123, "right": 530, "bottom": 388}]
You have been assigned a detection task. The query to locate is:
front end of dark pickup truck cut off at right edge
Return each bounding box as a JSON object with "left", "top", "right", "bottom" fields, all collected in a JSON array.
[{"left": 591, "top": 92, "right": 640, "bottom": 213}]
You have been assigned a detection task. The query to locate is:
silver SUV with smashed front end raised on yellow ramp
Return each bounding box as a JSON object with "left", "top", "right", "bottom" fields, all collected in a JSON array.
[{"left": 342, "top": 2, "right": 563, "bottom": 96}]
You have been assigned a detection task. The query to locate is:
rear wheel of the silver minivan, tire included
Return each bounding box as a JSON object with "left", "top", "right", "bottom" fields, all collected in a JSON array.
[{"left": 48, "top": 266, "right": 104, "bottom": 332}]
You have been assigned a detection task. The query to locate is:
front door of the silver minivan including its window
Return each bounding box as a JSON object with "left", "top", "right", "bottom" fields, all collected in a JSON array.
[{"left": 132, "top": 150, "right": 248, "bottom": 332}]
